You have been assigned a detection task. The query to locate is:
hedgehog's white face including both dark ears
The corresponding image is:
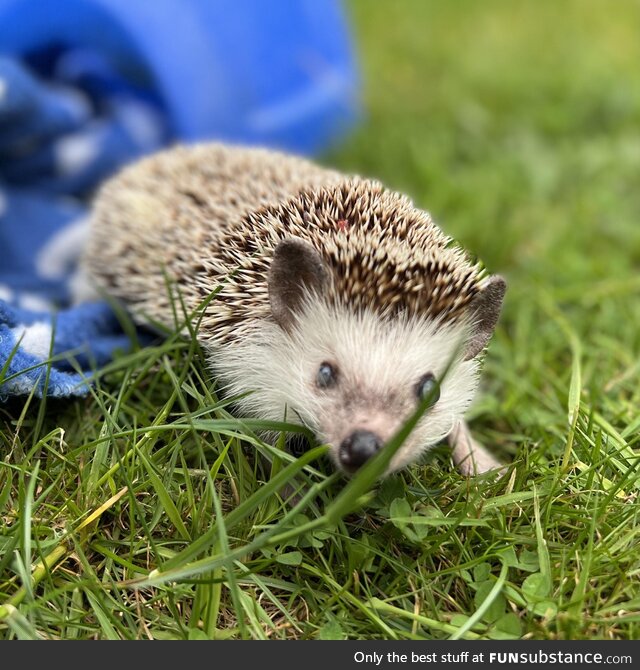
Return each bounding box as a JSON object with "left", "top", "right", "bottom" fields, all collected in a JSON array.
[{"left": 254, "top": 240, "right": 504, "bottom": 472}]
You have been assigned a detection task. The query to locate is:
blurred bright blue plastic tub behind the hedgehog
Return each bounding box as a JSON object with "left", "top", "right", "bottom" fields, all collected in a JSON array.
[{"left": 0, "top": 0, "right": 358, "bottom": 153}]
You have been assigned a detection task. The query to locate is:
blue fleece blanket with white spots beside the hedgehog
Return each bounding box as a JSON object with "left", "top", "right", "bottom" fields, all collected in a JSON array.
[{"left": 0, "top": 53, "right": 167, "bottom": 397}]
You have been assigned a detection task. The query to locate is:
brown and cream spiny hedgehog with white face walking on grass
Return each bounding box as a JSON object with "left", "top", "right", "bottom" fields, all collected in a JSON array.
[{"left": 83, "top": 144, "right": 506, "bottom": 475}]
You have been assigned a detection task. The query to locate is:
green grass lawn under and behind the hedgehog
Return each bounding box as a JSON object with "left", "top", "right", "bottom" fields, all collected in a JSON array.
[{"left": 0, "top": 0, "right": 640, "bottom": 639}]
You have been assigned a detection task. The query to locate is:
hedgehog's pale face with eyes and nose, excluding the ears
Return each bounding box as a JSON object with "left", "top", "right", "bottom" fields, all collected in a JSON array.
[{"left": 272, "top": 300, "right": 479, "bottom": 473}]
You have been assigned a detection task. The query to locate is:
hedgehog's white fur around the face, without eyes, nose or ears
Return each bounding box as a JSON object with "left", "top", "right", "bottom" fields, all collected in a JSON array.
[{"left": 210, "top": 298, "right": 480, "bottom": 471}]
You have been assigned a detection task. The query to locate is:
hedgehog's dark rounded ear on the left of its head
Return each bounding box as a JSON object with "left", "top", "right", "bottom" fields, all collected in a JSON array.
[{"left": 268, "top": 237, "right": 329, "bottom": 330}]
